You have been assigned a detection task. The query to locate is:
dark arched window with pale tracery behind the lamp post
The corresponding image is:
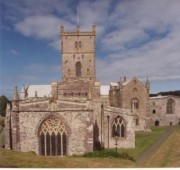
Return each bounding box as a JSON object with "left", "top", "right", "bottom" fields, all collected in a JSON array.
[{"left": 112, "top": 116, "right": 126, "bottom": 138}]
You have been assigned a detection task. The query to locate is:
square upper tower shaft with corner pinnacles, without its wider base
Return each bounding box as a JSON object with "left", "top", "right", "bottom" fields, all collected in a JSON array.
[{"left": 61, "top": 25, "right": 96, "bottom": 82}]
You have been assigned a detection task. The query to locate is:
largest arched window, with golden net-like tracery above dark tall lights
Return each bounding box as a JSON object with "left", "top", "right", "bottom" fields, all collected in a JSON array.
[{"left": 39, "top": 116, "right": 67, "bottom": 156}]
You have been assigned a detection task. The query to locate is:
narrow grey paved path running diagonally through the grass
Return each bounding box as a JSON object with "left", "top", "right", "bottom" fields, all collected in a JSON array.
[{"left": 136, "top": 126, "right": 173, "bottom": 164}]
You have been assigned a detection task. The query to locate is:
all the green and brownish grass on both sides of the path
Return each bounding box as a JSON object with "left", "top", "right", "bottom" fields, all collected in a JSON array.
[{"left": 0, "top": 126, "right": 180, "bottom": 168}]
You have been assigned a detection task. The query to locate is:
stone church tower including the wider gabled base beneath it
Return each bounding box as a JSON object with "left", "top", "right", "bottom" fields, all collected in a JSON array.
[{"left": 51, "top": 25, "right": 100, "bottom": 100}]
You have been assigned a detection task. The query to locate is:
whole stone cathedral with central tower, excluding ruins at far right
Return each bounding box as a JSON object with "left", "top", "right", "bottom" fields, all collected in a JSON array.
[{"left": 5, "top": 26, "right": 152, "bottom": 156}]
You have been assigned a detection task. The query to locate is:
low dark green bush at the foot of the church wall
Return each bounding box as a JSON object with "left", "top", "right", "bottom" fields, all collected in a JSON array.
[{"left": 83, "top": 149, "right": 134, "bottom": 161}]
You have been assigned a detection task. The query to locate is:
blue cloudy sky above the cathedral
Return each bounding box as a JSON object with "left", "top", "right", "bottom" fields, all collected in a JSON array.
[{"left": 0, "top": 0, "right": 180, "bottom": 98}]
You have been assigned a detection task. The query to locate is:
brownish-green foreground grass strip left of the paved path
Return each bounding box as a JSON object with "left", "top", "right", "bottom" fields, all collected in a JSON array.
[{"left": 0, "top": 149, "right": 134, "bottom": 168}]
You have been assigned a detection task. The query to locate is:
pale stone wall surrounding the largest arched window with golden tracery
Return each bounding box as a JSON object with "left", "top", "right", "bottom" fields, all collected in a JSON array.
[{"left": 19, "top": 110, "right": 93, "bottom": 155}]
